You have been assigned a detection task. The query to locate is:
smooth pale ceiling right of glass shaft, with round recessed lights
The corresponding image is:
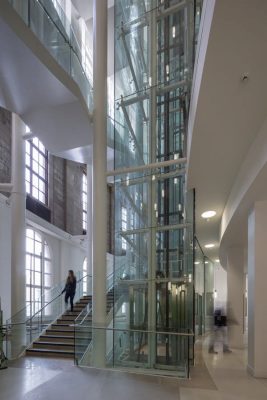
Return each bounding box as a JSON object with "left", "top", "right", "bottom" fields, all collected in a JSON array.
[{"left": 188, "top": 0, "right": 267, "bottom": 259}]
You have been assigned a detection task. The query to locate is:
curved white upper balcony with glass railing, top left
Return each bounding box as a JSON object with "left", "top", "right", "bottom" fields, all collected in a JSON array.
[{"left": 0, "top": 0, "right": 96, "bottom": 162}]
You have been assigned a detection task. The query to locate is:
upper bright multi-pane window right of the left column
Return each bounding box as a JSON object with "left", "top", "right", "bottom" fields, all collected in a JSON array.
[{"left": 25, "top": 138, "right": 48, "bottom": 205}]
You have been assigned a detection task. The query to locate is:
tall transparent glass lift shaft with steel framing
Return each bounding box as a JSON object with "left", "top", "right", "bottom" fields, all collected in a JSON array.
[{"left": 110, "top": 0, "right": 202, "bottom": 376}]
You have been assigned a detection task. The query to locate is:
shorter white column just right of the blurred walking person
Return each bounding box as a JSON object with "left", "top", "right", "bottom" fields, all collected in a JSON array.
[{"left": 227, "top": 247, "right": 244, "bottom": 348}]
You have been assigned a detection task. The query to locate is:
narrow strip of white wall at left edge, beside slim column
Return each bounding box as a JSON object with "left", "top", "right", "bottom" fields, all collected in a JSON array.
[{"left": 0, "top": 194, "right": 11, "bottom": 323}]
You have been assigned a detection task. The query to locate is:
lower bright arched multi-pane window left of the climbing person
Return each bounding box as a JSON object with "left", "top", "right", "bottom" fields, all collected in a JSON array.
[{"left": 26, "top": 228, "right": 52, "bottom": 315}]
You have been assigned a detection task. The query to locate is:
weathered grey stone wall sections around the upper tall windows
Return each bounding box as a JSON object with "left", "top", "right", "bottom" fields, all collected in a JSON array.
[{"left": 0, "top": 107, "right": 114, "bottom": 245}]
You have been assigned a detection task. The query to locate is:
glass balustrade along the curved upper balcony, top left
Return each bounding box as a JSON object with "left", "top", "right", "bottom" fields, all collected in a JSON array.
[{"left": 8, "top": 0, "right": 93, "bottom": 111}]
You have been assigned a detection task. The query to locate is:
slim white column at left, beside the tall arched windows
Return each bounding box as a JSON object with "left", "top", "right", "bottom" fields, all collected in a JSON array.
[{"left": 11, "top": 114, "right": 26, "bottom": 355}]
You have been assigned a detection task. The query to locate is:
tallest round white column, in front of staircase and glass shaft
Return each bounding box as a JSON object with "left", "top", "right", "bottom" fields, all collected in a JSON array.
[{"left": 93, "top": 0, "right": 107, "bottom": 367}]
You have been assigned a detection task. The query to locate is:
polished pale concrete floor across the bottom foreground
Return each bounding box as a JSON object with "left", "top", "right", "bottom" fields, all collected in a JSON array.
[{"left": 0, "top": 339, "right": 267, "bottom": 400}]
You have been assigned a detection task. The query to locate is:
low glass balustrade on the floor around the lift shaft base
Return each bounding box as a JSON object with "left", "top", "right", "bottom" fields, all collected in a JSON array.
[{"left": 75, "top": 320, "right": 193, "bottom": 378}]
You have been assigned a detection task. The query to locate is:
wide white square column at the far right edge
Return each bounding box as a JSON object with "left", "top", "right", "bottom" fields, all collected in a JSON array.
[{"left": 248, "top": 201, "right": 267, "bottom": 378}]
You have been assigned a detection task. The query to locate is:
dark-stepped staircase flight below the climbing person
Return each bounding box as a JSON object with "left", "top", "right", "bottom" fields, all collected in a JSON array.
[{"left": 26, "top": 296, "right": 92, "bottom": 358}]
